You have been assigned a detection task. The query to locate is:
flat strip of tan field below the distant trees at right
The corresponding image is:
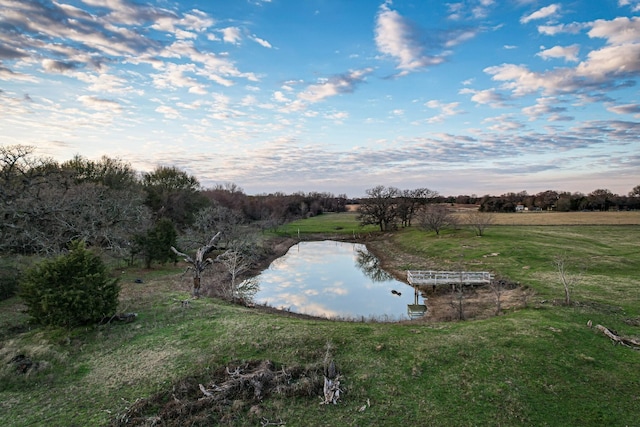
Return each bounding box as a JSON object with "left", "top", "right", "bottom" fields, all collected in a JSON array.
[{"left": 476, "top": 211, "right": 640, "bottom": 225}]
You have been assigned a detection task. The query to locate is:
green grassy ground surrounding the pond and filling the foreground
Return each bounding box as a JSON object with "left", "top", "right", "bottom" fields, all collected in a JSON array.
[{"left": 0, "top": 214, "right": 640, "bottom": 426}]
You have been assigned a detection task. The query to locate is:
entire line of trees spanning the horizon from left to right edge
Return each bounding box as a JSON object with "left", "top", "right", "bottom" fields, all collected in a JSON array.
[{"left": 0, "top": 145, "right": 640, "bottom": 265}]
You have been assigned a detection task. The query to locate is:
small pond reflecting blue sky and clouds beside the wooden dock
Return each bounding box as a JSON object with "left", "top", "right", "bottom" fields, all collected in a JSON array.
[{"left": 254, "top": 240, "right": 424, "bottom": 321}]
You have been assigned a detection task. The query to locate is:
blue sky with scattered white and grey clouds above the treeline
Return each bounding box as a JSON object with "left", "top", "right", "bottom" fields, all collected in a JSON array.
[{"left": 0, "top": 0, "right": 640, "bottom": 197}]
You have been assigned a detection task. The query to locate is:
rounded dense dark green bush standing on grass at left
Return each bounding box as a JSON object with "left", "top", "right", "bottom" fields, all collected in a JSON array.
[{"left": 20, "top": 241, "right": 120, "bottom": 327}]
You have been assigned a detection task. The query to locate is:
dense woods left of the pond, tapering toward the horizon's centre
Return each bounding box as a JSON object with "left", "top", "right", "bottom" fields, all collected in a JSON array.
[{"left": 0, "top": 145, "right": 348, "bottom": 265}]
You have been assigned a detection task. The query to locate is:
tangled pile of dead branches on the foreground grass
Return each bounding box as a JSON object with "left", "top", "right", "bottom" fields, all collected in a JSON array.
[{"left": 111, "top": 360, "right": 332, "bottom": 426}]
